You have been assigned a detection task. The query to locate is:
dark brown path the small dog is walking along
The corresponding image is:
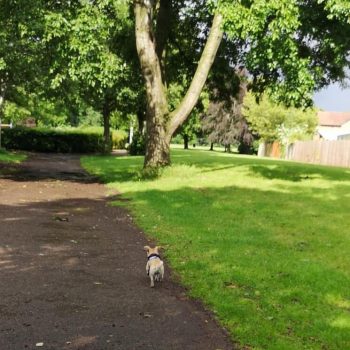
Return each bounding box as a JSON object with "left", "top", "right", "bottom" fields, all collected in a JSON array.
[{"left": 0, "top": 154, "right": 232, "bottom": 350}]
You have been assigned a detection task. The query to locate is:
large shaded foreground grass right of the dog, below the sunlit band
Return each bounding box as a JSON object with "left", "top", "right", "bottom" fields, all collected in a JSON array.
[{"left": 113, "top": 183, "right": 350, "bottom": 349}]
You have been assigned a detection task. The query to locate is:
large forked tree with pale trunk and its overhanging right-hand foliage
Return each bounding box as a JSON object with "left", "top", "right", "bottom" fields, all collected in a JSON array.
[{"left": 133, "top": 0, "right": 350, "bottom": 167}]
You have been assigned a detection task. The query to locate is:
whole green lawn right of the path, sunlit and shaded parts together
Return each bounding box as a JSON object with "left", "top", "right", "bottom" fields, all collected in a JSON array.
[{"left": 82, "top": 150, "right": 350, "bottom": 350}]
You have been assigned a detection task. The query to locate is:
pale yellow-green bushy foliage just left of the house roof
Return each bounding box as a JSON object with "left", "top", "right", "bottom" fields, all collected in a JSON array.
[{"left": 243, "top": 94, "right": 318, "bottom": 145}]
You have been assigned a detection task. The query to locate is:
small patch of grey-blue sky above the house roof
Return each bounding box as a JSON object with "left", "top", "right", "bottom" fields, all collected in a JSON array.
[{"left": 314, "top": 84, "right": 350, "bottom": 112}]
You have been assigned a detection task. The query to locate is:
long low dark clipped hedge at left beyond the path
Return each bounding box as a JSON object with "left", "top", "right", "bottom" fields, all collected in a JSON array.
[{"left": 2, "top": 127, "right": 108, "bottom": 153}]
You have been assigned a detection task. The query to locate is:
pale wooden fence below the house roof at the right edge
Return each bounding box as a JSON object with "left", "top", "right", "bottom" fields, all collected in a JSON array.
[{"left": 286, "top": 140, "right": 350, "bottom": 167}]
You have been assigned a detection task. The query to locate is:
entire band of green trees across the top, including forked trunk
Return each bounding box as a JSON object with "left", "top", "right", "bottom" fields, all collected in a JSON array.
[{"left": 0, "top": 0, "right": 350, "bottom": 168}]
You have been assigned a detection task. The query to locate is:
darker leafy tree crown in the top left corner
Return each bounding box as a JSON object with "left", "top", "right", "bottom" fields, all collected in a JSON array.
[{"left": 0, "top": 0, "right": 44, "bottom": 117}]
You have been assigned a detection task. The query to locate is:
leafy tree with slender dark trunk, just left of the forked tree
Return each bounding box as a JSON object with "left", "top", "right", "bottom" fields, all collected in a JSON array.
[{"left": 45, "top": 0, "right": 143, "bottom": 151}]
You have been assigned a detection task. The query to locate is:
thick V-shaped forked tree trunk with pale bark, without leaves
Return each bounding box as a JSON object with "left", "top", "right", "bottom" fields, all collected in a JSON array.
[{"left": 134, "top": 0, "right": 223, "bottom": 168}]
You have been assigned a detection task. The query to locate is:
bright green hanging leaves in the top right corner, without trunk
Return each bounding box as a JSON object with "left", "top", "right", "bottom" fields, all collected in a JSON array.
[{"left": 219, "top": 0, "right": 350, "bottom": 106}]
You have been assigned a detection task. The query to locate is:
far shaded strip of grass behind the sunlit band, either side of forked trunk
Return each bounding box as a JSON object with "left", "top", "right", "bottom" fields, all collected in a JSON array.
[{"left": 84, "top": 150, "right": 350, "bottom": 189}]
